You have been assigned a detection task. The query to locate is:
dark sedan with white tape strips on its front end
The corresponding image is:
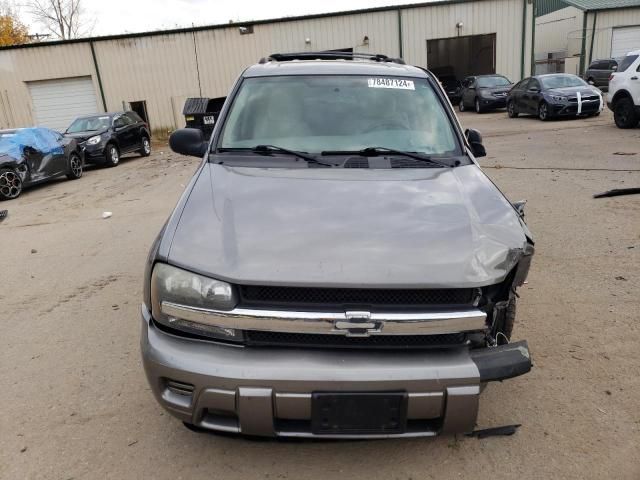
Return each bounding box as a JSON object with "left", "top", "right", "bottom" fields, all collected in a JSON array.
[{"left": 507, "top": 73, "right": 604, "bottom": 120}]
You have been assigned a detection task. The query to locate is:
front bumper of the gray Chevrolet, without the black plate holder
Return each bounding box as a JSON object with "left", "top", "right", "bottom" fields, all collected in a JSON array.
[{"left": 141, "top": 305, "right": 531, "bottom": 438}]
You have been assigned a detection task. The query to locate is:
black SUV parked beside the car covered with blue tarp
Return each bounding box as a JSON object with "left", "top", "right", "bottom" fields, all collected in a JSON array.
[{"left": 64, "top": 112, "right": 151, "bottom": 167}]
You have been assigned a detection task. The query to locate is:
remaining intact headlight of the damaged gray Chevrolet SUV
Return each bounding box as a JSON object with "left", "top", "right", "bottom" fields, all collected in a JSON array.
[{"left": 151, "top": 263, "right": 242, "bottom": 341}]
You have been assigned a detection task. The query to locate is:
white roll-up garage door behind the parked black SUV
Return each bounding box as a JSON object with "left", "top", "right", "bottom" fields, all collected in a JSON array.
[{"left": 27, "top": 77, "right": 98, "bottom": 131}]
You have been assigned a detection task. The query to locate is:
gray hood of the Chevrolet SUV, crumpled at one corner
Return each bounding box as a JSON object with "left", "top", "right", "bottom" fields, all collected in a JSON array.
[{"left": 168, "top": 164, "right": 526, "bottom": 288}]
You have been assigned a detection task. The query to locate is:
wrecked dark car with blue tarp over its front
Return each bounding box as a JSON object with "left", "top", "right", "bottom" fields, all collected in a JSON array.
[{"left": 0, "top": 128, "right": 83, "bottom": 200}]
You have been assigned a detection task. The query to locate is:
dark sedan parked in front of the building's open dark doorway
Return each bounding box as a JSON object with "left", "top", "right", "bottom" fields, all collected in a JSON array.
[{"left": 458, "top": 75, "right": 513, "bottom": 113}]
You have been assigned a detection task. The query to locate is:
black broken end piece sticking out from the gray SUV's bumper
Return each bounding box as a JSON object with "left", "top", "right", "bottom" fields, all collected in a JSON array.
[{"left": 470, "top": 340, "right": 531, "bottom": 382}]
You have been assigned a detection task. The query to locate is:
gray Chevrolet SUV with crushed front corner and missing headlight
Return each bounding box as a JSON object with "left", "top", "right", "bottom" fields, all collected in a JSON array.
[{"left": 141, "top": 53, "right": 533, "bottom": 438}]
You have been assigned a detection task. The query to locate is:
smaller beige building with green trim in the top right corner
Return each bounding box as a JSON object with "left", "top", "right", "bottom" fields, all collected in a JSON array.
[{"left": 535, "top": 0, "right": 640, "bottom": 74}]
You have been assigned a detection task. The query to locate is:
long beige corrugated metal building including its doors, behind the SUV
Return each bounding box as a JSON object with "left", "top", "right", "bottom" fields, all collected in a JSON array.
[{"left": 0, "top": 0, "right": 533, "bottom": 133}]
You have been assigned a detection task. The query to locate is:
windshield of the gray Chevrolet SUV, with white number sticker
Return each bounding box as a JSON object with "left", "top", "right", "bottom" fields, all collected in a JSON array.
[{"left": 218, "top": 75, "right": 460, "bottom": 155}]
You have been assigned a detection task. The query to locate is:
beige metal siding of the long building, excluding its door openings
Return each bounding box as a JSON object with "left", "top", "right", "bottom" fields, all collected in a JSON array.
[{"left": 0, "top": 0, "right": 531, "bottom": 134}]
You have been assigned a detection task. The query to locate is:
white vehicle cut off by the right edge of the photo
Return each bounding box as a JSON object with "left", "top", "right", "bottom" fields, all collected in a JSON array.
[{"left": 607, "top": 50, "right": 640, "bottom": 128}]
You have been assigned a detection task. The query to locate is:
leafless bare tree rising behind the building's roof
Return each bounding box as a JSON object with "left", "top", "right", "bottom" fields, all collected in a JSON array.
[{"left": 28, "top": 0, "right": 95, "bottom": 40}]
